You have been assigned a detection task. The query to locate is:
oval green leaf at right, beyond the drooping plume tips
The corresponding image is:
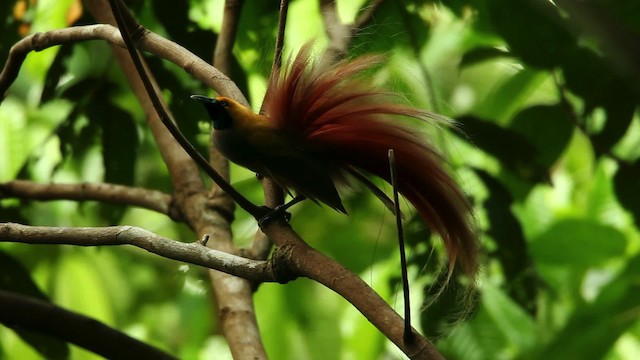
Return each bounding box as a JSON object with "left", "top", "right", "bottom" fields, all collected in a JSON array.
[{"left": 531, "top": 219, "right": 627, "bottom": 268}]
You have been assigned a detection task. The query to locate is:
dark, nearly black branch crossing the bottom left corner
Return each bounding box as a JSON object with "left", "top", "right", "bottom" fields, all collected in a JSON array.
[{"left": 0, "top": 290, "right": 176, "bottom": 359}]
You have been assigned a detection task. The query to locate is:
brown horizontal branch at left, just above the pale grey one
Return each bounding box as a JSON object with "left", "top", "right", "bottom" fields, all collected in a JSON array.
[{"left": 0, "top": 180, "right": 181, "bottom": 221}]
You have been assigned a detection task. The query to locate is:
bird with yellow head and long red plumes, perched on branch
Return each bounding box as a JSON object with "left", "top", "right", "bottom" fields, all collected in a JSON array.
[{"left": 191, "top": 43, "right": 478, "bottom": 275}]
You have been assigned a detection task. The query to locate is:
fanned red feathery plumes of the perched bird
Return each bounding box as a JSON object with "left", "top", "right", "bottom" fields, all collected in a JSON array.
[{"left": 264, "top": 44, "right": 477, "bottom": 274}]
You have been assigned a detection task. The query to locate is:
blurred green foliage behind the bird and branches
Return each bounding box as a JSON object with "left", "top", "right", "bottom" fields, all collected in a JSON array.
[{"left": 0, "top": 0, "right": 640, "bottom": 360}]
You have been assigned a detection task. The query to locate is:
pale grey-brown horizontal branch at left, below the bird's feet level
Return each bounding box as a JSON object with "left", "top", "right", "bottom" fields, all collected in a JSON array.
[{"left": 0, "top": 223, "right": 278, "bottom": 282}]
